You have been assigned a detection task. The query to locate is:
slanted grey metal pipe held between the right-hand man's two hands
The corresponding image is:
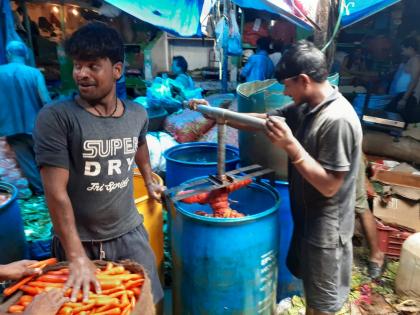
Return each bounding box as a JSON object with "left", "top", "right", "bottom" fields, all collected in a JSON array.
[{"left": 196, "top": 105, "right": 265, "bottom": 130}]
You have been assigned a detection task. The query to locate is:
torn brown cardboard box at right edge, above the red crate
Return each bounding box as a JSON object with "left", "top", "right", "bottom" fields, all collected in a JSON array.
[{"left": 373, "top": 171, "right": 420, "bottom": 232}]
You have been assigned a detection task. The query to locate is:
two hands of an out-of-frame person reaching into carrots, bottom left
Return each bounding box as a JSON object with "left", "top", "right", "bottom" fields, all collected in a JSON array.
[{"left": 0, "top": 260, "right": 68, "bottom": 315}]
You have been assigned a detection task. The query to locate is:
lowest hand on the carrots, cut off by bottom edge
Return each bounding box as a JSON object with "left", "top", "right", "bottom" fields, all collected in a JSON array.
[{"left": 23, "top": 289, "right": 68, "bottom": 315}]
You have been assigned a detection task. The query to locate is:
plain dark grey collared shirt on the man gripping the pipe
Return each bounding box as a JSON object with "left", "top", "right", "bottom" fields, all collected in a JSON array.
[{"left": 269, "top": 88, "right": 362, "bottom": 248}]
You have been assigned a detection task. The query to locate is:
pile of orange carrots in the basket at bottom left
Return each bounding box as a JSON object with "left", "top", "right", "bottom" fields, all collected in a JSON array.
[{"left": 5, "top": 263, "right": 144, "bottom": 315}]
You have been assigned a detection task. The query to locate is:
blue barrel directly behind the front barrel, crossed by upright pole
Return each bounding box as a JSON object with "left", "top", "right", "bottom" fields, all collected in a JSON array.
[{"left": 163, "top": 142, "right": 239, "bottom": 187}]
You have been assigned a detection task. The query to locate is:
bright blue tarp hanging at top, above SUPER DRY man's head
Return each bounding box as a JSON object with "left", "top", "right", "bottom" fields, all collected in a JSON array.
[{"left": 106, "top": 0, "right": 205, "bottom": 37}]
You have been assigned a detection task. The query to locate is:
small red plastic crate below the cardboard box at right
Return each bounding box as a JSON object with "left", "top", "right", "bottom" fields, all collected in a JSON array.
[{"left": 376, "top": 221, "right": 413, "bottom": 260}]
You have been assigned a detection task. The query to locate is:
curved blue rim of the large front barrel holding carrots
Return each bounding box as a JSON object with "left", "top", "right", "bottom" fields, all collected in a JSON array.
[{"left": 174, "top": 180, "right": 281, "bottom": 225}]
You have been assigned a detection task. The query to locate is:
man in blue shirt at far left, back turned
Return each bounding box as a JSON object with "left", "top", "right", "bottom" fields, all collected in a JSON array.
[{"left": 0, "top": 41, "right": 51, "bottom": 194}]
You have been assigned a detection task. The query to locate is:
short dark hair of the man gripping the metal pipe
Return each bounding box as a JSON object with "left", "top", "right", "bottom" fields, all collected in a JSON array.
[{"left": 274, "top": 40, "right": 328, "bottom": 83}]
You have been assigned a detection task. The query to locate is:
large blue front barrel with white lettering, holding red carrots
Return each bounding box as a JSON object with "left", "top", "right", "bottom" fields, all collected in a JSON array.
[{"left": 171, "top": 179, "right": 280, "bottom": 315}]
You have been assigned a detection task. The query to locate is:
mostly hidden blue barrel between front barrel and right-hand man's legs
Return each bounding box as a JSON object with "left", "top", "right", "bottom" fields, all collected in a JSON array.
[{"left": 275, "top": 181, "right": 303, "bottom": 302}]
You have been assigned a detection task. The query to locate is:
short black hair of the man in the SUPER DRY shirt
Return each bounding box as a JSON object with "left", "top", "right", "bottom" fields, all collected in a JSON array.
[{"left": 65, "top": 22, "right": 124, "bottom": 64}]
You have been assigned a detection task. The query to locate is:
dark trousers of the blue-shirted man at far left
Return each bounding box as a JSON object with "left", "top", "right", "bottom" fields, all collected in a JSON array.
[{"left": 6, "top": 133, "right": 44, "bottom": 194}]
